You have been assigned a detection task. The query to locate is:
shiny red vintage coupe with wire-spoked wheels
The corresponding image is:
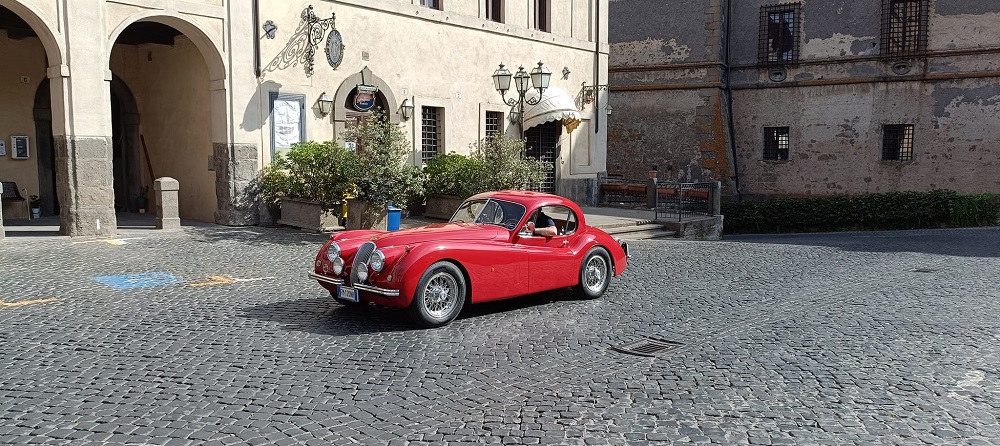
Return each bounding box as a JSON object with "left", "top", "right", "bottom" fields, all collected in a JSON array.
[{"left": 309, "top": 191, "right": 628, "bottom": 327}]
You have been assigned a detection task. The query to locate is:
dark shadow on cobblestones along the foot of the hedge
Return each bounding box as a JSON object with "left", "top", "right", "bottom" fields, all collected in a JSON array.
[{"left": 722, "top": 227, "right": 1000, "bottom": 257}]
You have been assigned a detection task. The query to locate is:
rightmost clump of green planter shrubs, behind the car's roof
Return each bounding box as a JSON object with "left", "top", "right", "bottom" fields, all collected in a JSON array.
[{"left": 424, "top": 135, "right": 552, "bottom": 219}]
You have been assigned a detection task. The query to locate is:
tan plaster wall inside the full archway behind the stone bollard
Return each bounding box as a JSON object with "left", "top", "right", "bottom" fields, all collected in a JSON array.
[{"left": 111, "top": 36, "right": 216, "bottom": 222}]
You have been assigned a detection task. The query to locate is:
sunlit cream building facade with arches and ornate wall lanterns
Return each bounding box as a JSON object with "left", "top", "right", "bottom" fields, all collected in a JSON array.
[{"left": 0, "top": 0, "right": 608, "bottom": 236}]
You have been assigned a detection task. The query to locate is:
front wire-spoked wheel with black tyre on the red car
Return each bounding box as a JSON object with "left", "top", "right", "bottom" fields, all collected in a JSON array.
[{"left": 409, "top": 261, "right": 466, "bottom": 328}]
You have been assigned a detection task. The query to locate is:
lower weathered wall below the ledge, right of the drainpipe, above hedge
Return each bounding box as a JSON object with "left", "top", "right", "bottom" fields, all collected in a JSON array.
[{"left": 736, "top": 80, "right": 1000, "bottom": 195}]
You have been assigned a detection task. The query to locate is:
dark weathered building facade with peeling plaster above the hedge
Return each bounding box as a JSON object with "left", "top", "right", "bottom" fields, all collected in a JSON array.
[{"left": 608, "top": 0, "right": 1000, "bottom": 197}]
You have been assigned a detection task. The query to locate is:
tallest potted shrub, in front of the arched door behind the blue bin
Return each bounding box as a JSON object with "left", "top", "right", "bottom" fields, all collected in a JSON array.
[{"left": 344, "top": 109, "right": 423, "bottom": 229}]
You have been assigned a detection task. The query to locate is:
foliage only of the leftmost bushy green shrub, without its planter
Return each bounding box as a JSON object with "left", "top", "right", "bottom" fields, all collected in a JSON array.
[{"left": 255, "top": 141, "right": 357, "bottom": 210}]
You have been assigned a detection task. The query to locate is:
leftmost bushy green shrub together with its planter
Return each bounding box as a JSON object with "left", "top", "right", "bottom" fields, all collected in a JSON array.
[{"left": 252, "top": 141, "right": 356, "bottom": 231}]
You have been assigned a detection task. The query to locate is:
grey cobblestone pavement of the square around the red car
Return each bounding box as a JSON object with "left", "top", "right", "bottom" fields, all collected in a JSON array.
[{"left": 0, "top": 226, "right": 1000, "bottom": 445}]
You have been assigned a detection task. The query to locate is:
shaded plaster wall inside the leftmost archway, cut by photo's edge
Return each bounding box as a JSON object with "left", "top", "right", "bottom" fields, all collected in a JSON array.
[{"left": 0, "top": 31, "right": 45, "bottom": 206}]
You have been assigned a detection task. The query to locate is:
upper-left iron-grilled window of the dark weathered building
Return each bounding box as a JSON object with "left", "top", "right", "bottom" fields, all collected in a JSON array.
[{"left": 757, "top": 3, "right": 802, "bottom": 65}]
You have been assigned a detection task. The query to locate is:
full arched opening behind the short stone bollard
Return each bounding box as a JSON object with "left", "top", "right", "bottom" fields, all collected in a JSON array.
[{"left": 109, "top": 17, "right": 224, "bottom": 222}]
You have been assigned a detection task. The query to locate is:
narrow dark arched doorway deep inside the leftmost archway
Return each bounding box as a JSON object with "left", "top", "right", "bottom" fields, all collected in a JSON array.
[{"left": 32, "top": 78, "right": 59, "bottom": 216}]
